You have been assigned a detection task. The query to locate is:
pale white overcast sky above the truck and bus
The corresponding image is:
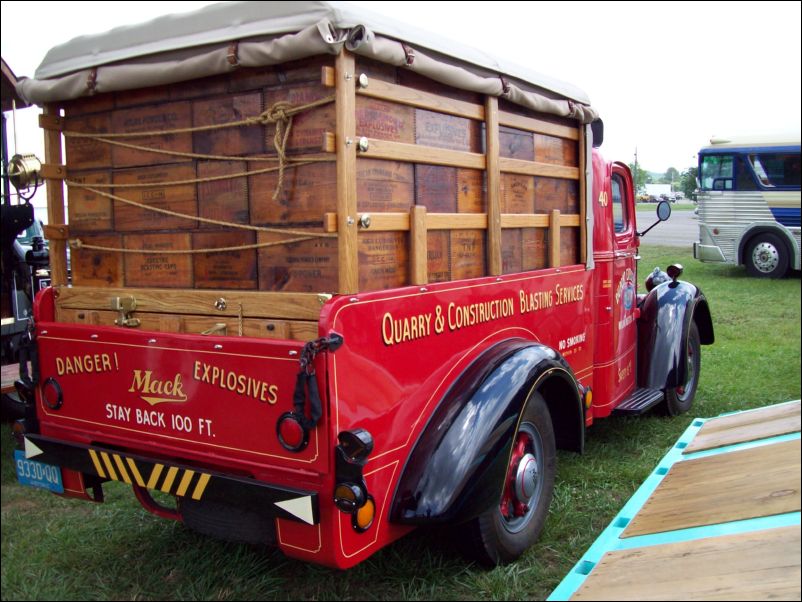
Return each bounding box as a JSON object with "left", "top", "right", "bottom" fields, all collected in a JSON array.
[{"left": 0, "top": 1, "right": 802, "bottom": 211}]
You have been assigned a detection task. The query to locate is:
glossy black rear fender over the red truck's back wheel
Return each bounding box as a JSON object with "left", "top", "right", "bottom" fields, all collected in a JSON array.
[{"left": 390, "top": 339, "right": 585, "bottom": 525}]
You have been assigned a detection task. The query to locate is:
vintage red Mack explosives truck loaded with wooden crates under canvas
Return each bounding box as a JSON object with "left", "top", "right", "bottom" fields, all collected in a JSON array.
[{"left": 10, "top": 2, "right": 713, "bottom": 568}]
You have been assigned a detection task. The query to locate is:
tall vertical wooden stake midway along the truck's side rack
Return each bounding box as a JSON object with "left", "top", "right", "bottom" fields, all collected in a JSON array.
[{"left": 485, "top": 96, "right": 503, "bottom": 276}]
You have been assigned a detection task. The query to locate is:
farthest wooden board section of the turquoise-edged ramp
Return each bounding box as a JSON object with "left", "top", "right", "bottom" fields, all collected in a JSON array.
[{"left": 683, "top": 401, "right": 802, "bottom": 454}]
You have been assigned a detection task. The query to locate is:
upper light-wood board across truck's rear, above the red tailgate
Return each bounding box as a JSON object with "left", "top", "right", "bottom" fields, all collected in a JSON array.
[{"left": 56, "top": 286, "right": 327, "bottom": 321}]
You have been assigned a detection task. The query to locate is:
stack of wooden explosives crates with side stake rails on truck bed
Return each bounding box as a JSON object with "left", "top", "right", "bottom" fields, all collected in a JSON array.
[{"left": 54, "top": 48, "right": 586, "bottom": 310}]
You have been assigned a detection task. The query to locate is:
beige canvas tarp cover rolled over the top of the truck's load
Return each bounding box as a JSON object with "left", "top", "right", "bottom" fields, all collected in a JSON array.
[{"left": 17, "top": 2, "right": 597, "bottom": 123}]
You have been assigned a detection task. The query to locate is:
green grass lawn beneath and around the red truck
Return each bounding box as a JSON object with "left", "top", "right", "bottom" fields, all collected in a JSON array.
[{"left": 2, "top": 246, "right": 800, "bottom": 600}]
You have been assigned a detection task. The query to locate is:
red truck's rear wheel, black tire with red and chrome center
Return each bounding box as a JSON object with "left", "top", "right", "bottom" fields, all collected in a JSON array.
[{"left": 466, "top": 392, "right": 557, "bottom": 567}]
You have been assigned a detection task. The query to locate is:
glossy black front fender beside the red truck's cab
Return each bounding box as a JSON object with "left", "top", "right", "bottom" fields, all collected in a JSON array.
[{"left": 638, "top": 280, "right": 715, "bottom": 389}]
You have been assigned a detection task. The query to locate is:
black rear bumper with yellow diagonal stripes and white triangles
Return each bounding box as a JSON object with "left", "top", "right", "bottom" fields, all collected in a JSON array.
[{"left": 25, "top": 434, "right": 320, "bottom": 525}]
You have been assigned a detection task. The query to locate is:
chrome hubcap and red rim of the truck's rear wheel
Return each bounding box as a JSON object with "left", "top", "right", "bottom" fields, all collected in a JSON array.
[{"left": 499, "top": 423, "right": 543, "bottom": 533}]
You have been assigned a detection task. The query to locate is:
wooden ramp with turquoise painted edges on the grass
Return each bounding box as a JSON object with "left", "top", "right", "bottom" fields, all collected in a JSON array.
[{"left": 549, "top": 400, "right": 802, "bottom": 600}]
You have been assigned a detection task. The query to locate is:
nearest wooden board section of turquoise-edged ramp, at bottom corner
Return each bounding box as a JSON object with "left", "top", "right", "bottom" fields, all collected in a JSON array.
[{"left": 571, "top": 525, "right": 800, "bottom": 600}]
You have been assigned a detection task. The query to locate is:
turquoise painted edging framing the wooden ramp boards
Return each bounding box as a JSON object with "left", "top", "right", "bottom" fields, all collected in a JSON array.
[{"left": 546, "top": 400, "right": 800, "bottom": 600}]
